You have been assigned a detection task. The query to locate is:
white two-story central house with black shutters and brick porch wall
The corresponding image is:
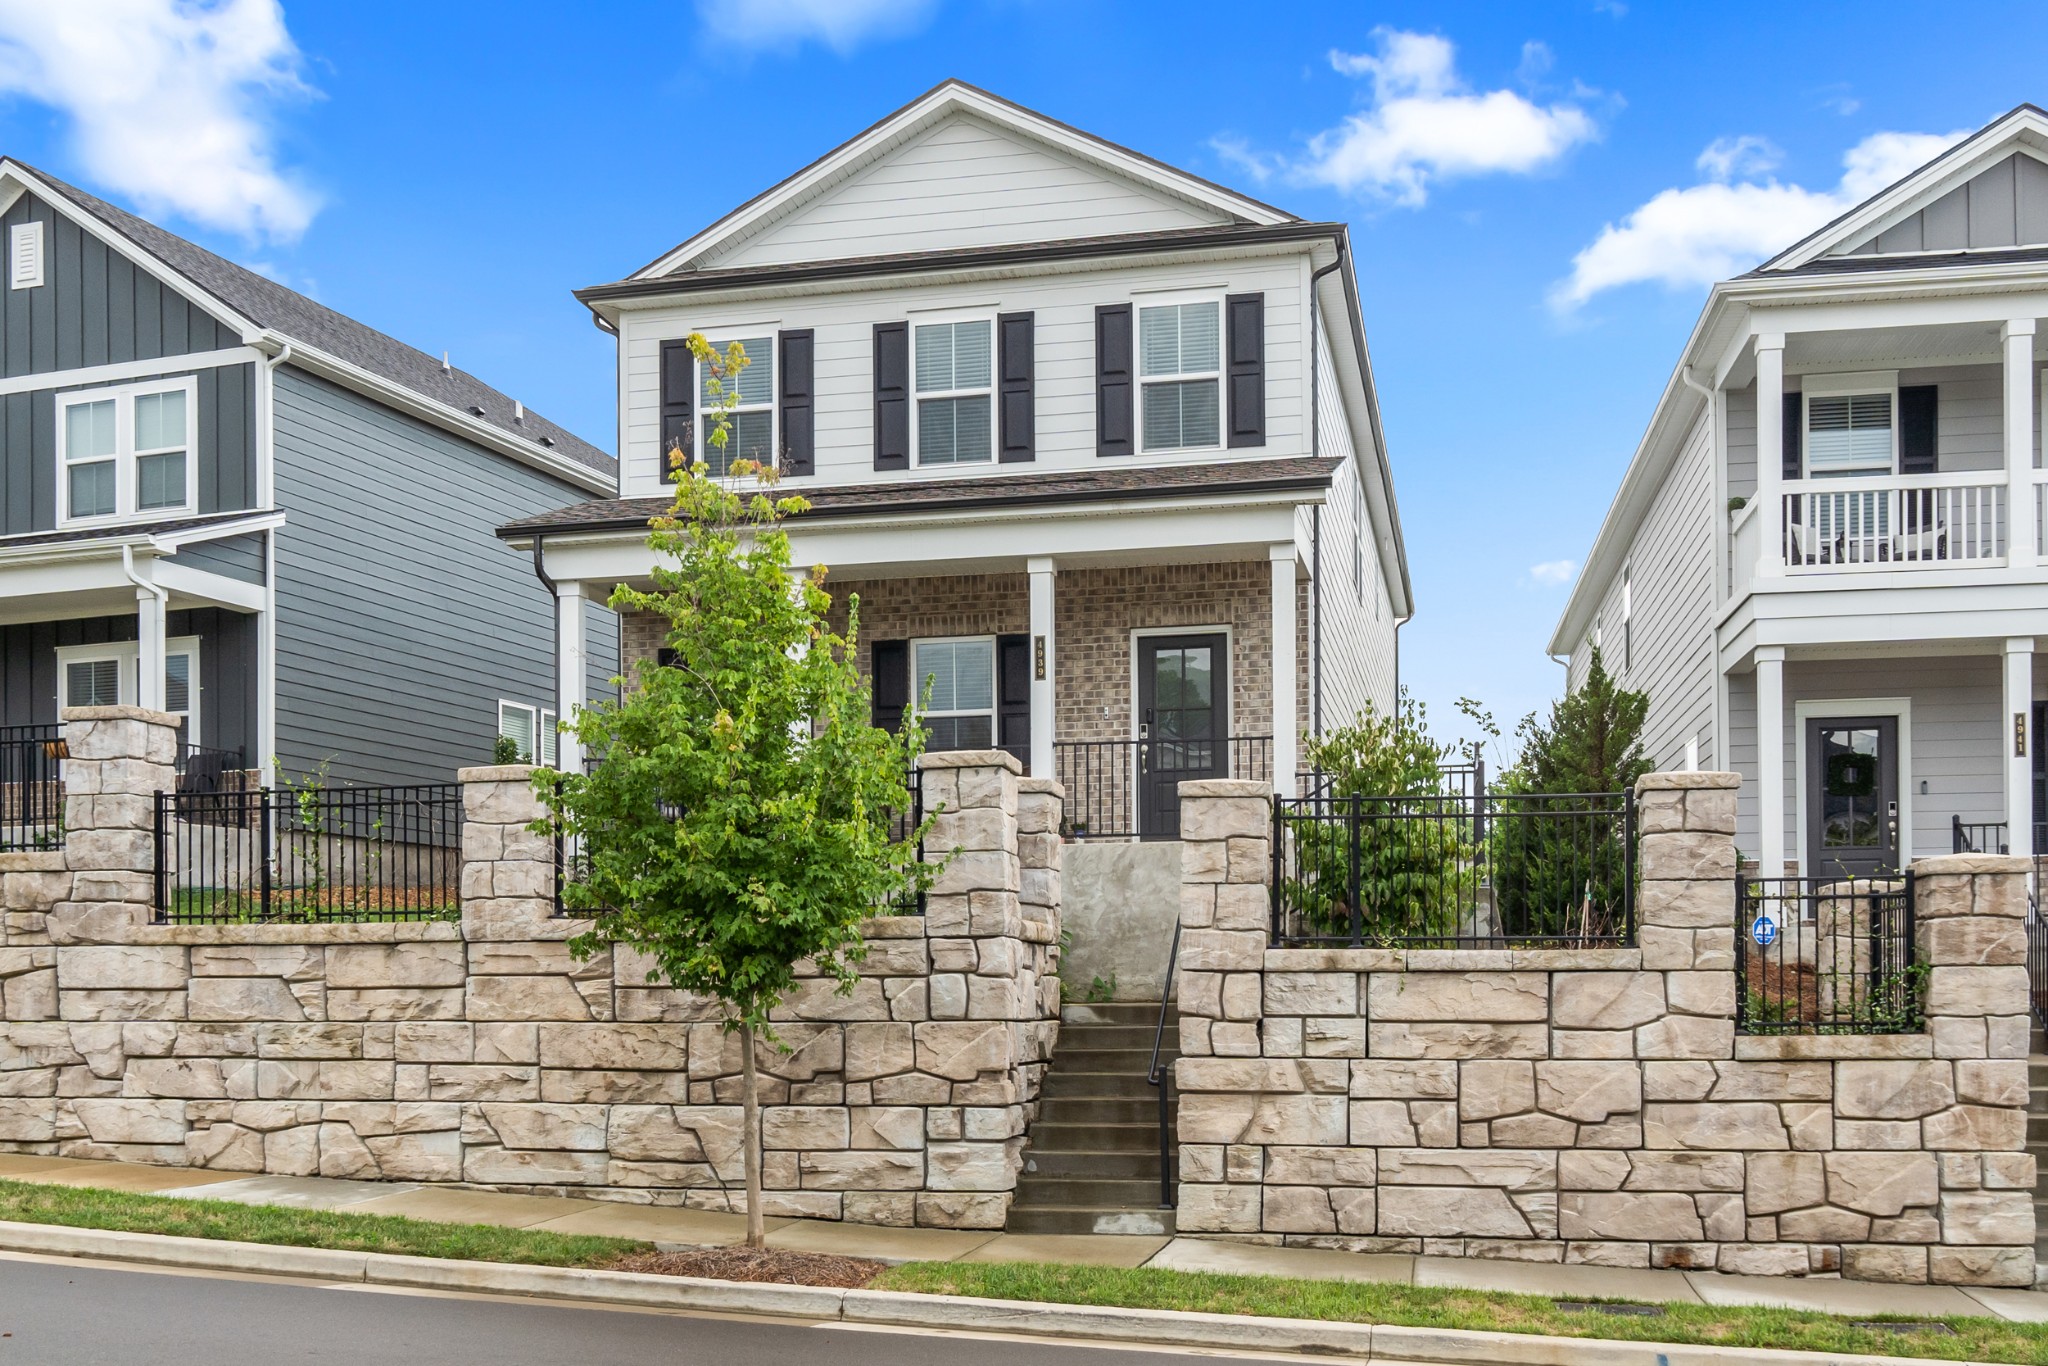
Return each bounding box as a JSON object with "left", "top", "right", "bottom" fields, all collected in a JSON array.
[{"left": 500, "top": 82, "right": 1413, "bottom": 838}]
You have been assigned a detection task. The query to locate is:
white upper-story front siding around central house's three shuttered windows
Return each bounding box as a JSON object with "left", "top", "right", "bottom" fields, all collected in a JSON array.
[{"left": 621, "top": 256, "right": 1309, "bottom": 498}]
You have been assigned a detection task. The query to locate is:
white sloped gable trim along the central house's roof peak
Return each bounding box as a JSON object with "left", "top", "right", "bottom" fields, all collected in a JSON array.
[{"left": 627, "top": 80, "right": 1294, "bottom": 281}]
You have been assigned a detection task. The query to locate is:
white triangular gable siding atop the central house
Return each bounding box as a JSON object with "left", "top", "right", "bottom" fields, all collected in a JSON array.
[{"left": 700, "top": 115, "right": 1229, "bottom": 268}]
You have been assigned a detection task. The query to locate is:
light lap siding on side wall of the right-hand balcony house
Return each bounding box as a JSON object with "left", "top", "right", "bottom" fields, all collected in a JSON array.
[{"left": 1569, "top": 412, "right": 1720, "bottom": 770}]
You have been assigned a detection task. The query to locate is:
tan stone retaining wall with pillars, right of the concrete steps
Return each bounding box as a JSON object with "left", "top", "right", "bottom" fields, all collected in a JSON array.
[{"left": 1176, "top": 774, "right": 2034, "bottom": 1286}]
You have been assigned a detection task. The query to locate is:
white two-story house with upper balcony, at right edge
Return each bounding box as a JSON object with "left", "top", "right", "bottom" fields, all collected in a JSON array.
[{"left": 1550, "top": 106, "right": 2048, "bottom": 877}]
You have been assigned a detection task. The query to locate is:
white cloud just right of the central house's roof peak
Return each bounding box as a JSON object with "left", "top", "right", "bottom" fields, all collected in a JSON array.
[{"left": 1212, "top": 29, "right": 1597, "bottom": 207}]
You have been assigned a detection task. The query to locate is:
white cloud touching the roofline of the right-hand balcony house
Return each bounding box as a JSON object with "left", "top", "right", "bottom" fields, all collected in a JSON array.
[{"left": 1550, "top": 129, "right": 1968, "bottom": 311}]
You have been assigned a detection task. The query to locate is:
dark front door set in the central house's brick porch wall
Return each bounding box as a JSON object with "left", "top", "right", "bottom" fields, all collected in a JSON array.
[{"left": 1139, "top": 635, "right": 1231, "bottom": 840}]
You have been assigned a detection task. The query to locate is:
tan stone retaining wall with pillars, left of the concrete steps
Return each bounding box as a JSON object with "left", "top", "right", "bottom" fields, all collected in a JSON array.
[{"left": 0, "top": 709, "right": 1061, "bottom": 1229}]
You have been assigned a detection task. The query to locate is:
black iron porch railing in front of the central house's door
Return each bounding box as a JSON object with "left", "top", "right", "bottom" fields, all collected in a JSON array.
[{"left": 1053, "top": 735, "right": 1274, "bottom": 840}]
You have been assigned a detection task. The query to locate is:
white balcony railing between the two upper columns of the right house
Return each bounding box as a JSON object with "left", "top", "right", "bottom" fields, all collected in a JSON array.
[{"left": 1784, "top": 471, "right": 2005, "bottom": 573}]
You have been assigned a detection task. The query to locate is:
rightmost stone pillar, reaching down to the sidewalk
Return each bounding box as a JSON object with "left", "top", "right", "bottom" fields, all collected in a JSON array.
[{"left": 1913, "top": 854, "right": 2034, "bottom": 1286}]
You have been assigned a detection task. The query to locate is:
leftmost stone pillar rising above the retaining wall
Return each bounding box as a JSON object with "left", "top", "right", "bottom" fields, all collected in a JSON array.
[{"left": 49, "top": 707, "right": 178, "bottom": 942}]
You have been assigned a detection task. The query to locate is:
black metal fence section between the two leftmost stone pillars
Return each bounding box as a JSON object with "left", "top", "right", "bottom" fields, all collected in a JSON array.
[{"left": 156, "top": 782, "right": 463, "bottom": 924}]
